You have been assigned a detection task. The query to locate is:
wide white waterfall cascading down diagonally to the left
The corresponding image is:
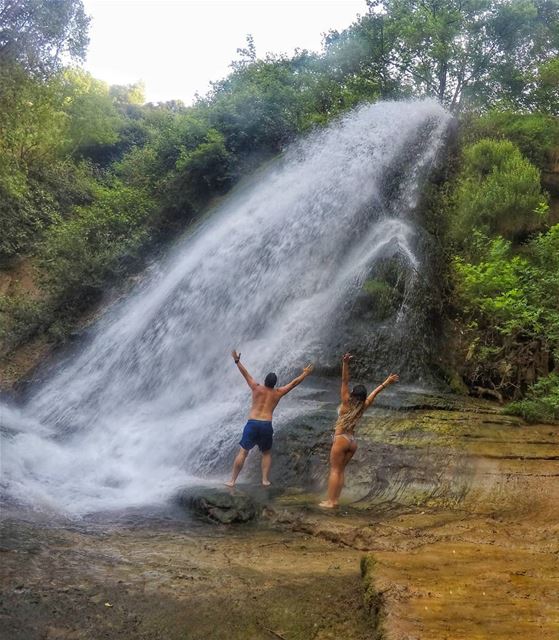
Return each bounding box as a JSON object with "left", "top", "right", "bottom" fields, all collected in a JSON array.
[{"left": 0, "top": 101, "right": 449, "bottom": 513}]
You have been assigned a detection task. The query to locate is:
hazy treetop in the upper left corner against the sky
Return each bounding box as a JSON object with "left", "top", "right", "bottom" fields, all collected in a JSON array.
[{"left": 0, "top": 0, "right": 89, "bottom": 76}]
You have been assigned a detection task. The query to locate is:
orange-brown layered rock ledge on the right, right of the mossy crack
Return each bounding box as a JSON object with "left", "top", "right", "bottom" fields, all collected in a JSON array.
[{"left": 276, "top": 411, "right": 559, "bottom": 640}]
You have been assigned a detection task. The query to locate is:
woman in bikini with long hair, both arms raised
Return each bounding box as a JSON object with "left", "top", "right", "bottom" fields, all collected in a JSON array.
[{"left": 319, "top": 353, "right": 399, "bottom": 509}]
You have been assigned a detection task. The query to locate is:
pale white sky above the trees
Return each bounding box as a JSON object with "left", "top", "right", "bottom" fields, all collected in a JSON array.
[{"left": 84, "top": 0, "right": 367, "bottom": 104}]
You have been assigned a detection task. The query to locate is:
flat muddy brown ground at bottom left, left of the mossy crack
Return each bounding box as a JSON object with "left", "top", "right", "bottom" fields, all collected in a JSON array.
[{"left": 0, "top": 521, "right": 372, "bottom": 640}]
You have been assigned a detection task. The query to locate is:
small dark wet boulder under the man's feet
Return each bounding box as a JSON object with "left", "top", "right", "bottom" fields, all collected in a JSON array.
[{"left": 177, "top": 487, "right": 262, "bottom": 524}]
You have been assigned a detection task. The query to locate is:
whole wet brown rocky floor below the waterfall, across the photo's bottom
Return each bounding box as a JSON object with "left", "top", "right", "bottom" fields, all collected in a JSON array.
[{"left": 0, "top": 396, "right": 559, "bottom": 640}]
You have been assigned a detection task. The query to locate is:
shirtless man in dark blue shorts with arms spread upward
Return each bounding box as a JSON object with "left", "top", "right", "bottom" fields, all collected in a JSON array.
[{"left": 225, "top": 351, "right": 313, "bottom": 487}]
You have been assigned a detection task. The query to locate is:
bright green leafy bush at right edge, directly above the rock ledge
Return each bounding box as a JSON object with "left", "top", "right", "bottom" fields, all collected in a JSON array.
[{"left": 453, "top": 225, "right": 559, "bottom": 397}]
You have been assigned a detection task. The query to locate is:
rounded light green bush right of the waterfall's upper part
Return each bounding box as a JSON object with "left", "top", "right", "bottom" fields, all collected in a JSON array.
[{"left": 451, "top": 139, "right": 547, "bottom": 245}]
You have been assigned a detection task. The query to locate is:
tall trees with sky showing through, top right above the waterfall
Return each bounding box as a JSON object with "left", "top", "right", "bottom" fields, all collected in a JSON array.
[{"left": 326, "top": 0, "right": 559, "bottom": 111}]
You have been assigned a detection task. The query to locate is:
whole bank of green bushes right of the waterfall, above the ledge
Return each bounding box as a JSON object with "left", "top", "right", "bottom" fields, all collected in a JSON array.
[{"left": 441, "top": 120, "right": 559, "bottom": 410}]
